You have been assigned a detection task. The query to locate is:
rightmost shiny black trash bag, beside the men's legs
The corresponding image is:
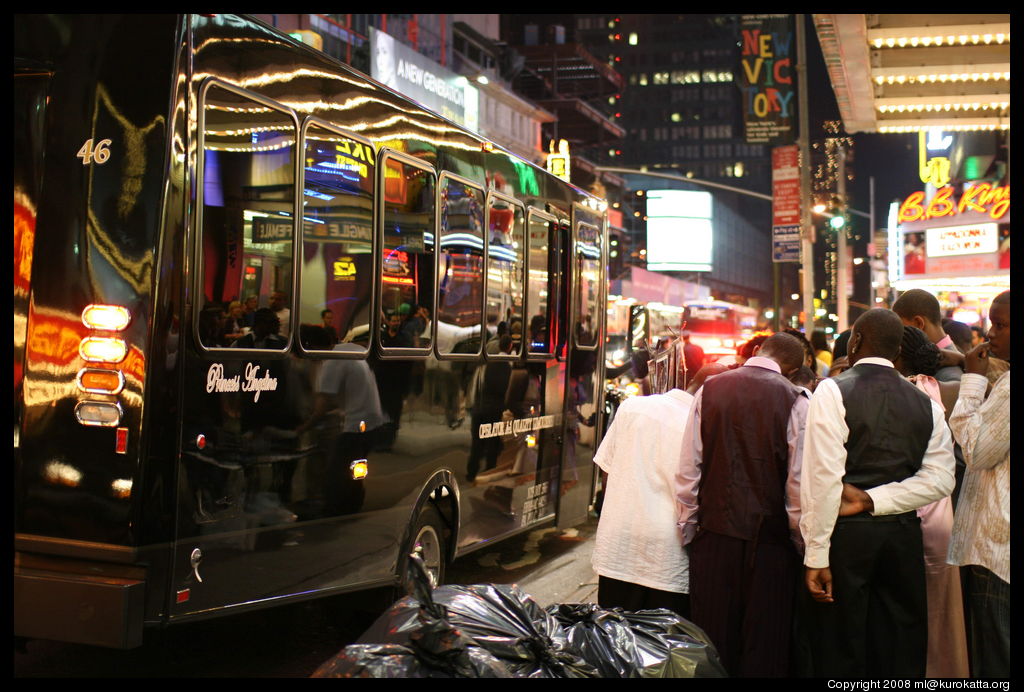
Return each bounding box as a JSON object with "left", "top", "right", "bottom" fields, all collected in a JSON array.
[{"left": 547, "top": 603, "right": 726, "bottom": 678}]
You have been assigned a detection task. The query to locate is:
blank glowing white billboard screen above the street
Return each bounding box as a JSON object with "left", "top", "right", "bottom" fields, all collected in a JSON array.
[{"left": 647, "top": 189, "right": 714, "bottom": 271}]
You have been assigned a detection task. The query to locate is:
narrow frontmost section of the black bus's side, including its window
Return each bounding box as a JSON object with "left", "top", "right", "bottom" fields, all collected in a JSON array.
[{"left": 558, "top": 207, "right": 605, "bottom": 527}]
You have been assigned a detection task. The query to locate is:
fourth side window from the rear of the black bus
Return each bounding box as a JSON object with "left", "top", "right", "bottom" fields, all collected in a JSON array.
[{"left": 437, "top": 174, "right": 483, "bottom": 356}]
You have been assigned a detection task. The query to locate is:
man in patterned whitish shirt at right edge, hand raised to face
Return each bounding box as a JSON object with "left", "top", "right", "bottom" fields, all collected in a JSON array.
[{"left": 949, "top": 291, "right": 1010, "bottom": 678}]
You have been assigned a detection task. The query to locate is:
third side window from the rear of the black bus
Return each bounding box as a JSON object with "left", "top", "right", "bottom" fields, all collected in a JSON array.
[{"left": 380, "top": 152, "right": 437, "bottom": 353}]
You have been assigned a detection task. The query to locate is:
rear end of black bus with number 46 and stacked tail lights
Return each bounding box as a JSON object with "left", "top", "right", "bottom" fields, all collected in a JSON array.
[{"left": 14, "top": 14, "right": 182, "bottom": 646}]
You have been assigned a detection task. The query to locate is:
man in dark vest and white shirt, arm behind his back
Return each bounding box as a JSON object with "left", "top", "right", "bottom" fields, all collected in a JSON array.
[{"left": 800, "top": 308, "right": 953, "bottom": 679}]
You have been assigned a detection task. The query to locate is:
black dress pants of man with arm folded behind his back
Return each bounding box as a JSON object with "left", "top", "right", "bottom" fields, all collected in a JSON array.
[{"left": 800, "top": 512, "right": 928, "bottom": 679}]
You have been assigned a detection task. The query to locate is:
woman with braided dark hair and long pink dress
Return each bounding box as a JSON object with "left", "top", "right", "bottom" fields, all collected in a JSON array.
[{"left": 893, "top": 327, "right": 969, "bottom": 678}]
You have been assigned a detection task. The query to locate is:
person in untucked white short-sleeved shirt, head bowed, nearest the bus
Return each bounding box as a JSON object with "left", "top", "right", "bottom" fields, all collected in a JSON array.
[{"left": 593, "top": 365, "right": 725, "bottom": 618}]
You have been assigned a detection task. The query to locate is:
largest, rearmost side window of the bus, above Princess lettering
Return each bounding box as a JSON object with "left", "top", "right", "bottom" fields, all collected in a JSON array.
[{"left": 197, "top": 84, "right": 296, "bottom": 350}]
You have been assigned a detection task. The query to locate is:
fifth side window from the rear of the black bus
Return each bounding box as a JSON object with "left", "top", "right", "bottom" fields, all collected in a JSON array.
[{"left": 484, "top": 192, "right": 526, "bottom": 358}]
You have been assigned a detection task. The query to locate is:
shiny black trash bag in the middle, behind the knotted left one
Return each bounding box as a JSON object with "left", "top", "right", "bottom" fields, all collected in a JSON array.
[{"left": 357, "top": 561, "right": 598, "bottom": 678}]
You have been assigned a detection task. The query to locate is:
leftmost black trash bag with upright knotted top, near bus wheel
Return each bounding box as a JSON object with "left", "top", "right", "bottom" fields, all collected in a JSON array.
[{"left": 312, "top": 556, "right": 512, "bottom": 678}]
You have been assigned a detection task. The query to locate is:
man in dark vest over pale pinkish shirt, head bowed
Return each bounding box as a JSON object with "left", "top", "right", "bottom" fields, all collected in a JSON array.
[{"left": 676, "top": 333, "right": 809, "bottom": 677}]
